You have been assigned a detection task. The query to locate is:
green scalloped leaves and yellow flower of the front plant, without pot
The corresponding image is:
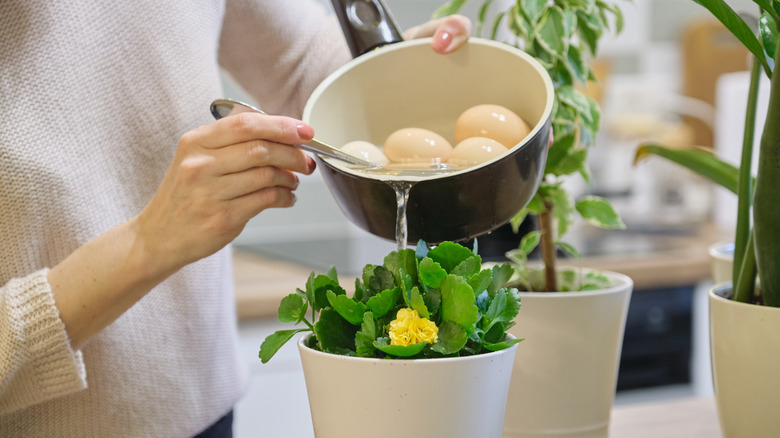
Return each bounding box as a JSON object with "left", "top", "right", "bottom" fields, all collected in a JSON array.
[{"left": 259, "top": 241, "right": 521, "bottom": 363}]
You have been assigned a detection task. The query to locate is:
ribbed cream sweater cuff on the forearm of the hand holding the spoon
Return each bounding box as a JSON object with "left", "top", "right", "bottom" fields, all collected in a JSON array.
[{"left": 0, "top": 269, "right": 87, "bottom": 415}]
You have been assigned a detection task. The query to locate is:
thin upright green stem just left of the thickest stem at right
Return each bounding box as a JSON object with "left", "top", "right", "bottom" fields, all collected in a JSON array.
[{"left": 732, "top": 58, "right": 764, "bottom": 290}]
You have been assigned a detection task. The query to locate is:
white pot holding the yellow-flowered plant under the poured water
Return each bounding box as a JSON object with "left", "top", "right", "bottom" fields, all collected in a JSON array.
[{"left": 298, "top": 339, "right": 523, "bottom": 438}]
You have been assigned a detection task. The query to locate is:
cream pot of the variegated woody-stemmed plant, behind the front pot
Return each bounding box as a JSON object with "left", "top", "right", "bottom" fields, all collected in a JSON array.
[{"left": 504, "top": 272, "right": 633, "bottom": 438}]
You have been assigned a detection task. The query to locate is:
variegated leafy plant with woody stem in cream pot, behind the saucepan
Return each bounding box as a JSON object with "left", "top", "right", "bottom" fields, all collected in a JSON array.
[{"left": 435, "top": 0, "right": 633, "bottom": 437}]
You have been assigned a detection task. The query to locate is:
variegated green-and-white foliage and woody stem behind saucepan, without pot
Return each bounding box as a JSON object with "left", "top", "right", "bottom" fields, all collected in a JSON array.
[{"left": 434, "top": 0, "right": 625, "bottom": 291}]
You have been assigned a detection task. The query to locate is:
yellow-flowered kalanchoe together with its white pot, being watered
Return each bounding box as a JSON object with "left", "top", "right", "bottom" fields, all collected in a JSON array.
[{"left": 259, "top": 242, "right": 521, "bottom": 438}]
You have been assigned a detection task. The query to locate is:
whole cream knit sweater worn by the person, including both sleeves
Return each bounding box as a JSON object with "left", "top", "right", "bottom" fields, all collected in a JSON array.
[{"left": 0, "top": 0, "right": 349, "bottom": 438}]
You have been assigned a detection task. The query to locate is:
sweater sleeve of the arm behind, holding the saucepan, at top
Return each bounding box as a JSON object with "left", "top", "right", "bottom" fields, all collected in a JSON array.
[{"left": 219, "top": 0, "right": 351, "bottom": 117}]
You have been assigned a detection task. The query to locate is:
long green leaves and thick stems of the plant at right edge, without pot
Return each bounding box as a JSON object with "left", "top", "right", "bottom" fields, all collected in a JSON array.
[{"left": 636, "top": 0, "right": 780, "bottom": 307}]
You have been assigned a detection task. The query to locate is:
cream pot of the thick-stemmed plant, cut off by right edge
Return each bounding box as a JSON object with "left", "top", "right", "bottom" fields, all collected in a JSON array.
[{"left": 709, "top": 285, "right": 780, "bottom": 438}]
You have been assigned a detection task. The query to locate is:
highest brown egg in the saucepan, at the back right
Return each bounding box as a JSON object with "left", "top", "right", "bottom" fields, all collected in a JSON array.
[{"left": 455, "top": 104, "right": 531, "bottom": 148}]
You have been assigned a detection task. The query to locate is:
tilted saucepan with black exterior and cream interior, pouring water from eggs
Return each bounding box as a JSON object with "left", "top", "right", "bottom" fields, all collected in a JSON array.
[{"left": 303, "top": 0, "right": 554, "bottom": 244}]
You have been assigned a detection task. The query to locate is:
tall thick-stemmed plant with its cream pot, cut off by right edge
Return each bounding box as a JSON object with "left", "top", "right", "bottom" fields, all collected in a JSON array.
[{"left": 637, "top": 0, "right": 780, "bottom": 437}]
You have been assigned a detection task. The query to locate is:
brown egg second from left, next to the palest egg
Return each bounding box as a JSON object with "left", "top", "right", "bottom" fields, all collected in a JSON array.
[{"left": 384, "top": 128, "right": 452, "bottom": 163}]
